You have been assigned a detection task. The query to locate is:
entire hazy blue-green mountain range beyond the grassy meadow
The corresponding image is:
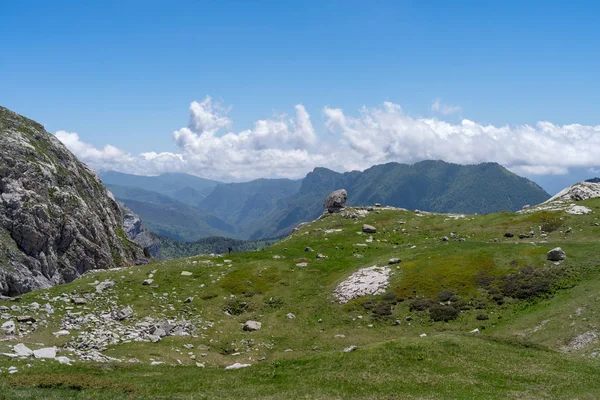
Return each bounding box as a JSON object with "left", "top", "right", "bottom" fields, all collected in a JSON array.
[{"left": 101, "top": 161, "right": 550, "bottom": 241}]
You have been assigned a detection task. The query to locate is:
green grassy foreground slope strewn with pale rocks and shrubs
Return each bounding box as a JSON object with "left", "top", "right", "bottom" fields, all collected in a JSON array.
[{"left": 0, "top": 185, "right": 600, "bottom": 399}]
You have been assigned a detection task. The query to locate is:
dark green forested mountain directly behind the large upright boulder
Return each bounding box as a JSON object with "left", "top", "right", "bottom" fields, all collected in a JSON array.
[{"left": 250, "top": 161, "right": 550, "bottom": 239}]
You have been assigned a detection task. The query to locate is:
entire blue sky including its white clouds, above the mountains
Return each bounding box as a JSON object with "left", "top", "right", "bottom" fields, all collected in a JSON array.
[{"left": 0, "top": 1, "right": 600, "bottom": 192}]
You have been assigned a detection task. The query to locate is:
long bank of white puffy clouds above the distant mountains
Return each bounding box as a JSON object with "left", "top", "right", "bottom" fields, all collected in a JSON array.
[{"left": 56, "top": 96, "right": 600, "bottom": 181}]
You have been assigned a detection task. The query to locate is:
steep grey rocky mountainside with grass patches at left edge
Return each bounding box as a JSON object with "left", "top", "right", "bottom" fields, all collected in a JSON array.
[{"left": 0, "top": 107, "right": 147, "bottom": 295}]
